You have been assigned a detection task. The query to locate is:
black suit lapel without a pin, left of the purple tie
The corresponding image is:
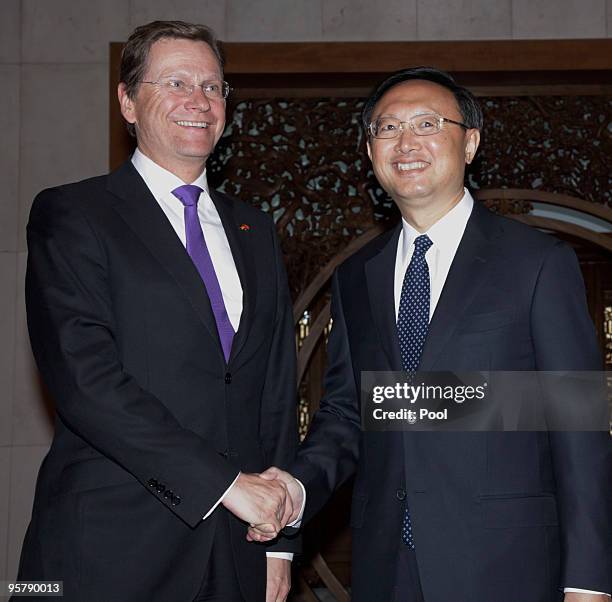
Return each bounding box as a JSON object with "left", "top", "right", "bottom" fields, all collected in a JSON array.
[{"left": 108, "top": 161, "right": 223, "bottom": 357}]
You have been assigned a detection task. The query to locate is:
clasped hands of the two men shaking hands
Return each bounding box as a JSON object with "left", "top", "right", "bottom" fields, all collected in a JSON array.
[{"left": 221, "top": 466, "right": 304, "bottom": 542}]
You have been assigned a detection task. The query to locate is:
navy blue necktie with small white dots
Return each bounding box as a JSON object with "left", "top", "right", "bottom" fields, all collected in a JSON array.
[{"left": 397, "top": 234, "right": 433, "bottom": 550}]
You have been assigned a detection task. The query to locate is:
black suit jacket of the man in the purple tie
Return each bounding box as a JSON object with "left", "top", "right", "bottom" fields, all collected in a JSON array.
[{"left": 20, "top": 162, "right": 297, "bottom": 602}]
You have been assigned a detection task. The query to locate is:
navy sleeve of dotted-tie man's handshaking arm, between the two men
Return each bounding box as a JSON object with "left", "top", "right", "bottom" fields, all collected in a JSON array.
[{"left": 291, "top": 273, "right": 361, "bottom": 521}]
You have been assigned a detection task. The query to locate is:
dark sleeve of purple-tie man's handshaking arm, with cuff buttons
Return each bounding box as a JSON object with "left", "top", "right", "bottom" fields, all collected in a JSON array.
[{"left": 26, "top": 189, "right": 236, "bottom": 526}]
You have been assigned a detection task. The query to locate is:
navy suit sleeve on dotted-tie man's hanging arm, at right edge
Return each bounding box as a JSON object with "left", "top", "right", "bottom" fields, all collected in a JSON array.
[{"left": 531, "top": 244, "right": 612, "bottom": 593}]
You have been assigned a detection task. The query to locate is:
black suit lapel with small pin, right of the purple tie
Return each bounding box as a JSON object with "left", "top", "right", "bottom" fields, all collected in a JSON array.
[{"left": 210, "top": 190, "right": 257, "bottom": 362}]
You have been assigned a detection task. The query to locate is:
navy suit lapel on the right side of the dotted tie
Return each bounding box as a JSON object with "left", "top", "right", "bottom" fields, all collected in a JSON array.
[{"left": 419, "top": 202, "right": 498, "bottom": 371}]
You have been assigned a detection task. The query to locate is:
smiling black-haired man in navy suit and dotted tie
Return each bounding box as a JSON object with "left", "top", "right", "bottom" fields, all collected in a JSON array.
[{"left": 251, "top": 68, "right": 612, "bottom": 602}]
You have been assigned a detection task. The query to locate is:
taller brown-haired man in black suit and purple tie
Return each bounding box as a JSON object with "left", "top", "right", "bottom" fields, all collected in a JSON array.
[{"left": 19, "top": 22, "right": 297, "bottom": 602}]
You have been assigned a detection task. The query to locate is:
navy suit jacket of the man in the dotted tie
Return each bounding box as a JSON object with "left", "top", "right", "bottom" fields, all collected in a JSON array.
[{"left": 291, "top": 200, "right": 612, "bottom": 602}]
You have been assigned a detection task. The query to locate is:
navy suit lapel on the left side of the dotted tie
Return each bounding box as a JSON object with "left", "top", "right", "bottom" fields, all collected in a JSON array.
[{"left": 365, "top": 222, "right": 402, "bottom": 370}]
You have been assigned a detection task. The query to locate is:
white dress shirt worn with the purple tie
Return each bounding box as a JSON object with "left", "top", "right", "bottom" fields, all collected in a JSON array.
[{"left": 132, "top": 148, "right": 306, "bottom": 560}]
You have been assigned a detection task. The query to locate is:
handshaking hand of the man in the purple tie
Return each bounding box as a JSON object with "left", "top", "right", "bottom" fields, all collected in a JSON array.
[{"left": 221, "top": 473, "right": 293, "bottom": 539}]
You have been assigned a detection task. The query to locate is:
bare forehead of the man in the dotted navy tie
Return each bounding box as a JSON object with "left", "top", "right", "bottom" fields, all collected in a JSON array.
[{"left": 373, "top": 79, "right": 459, "bottom": 114}]
